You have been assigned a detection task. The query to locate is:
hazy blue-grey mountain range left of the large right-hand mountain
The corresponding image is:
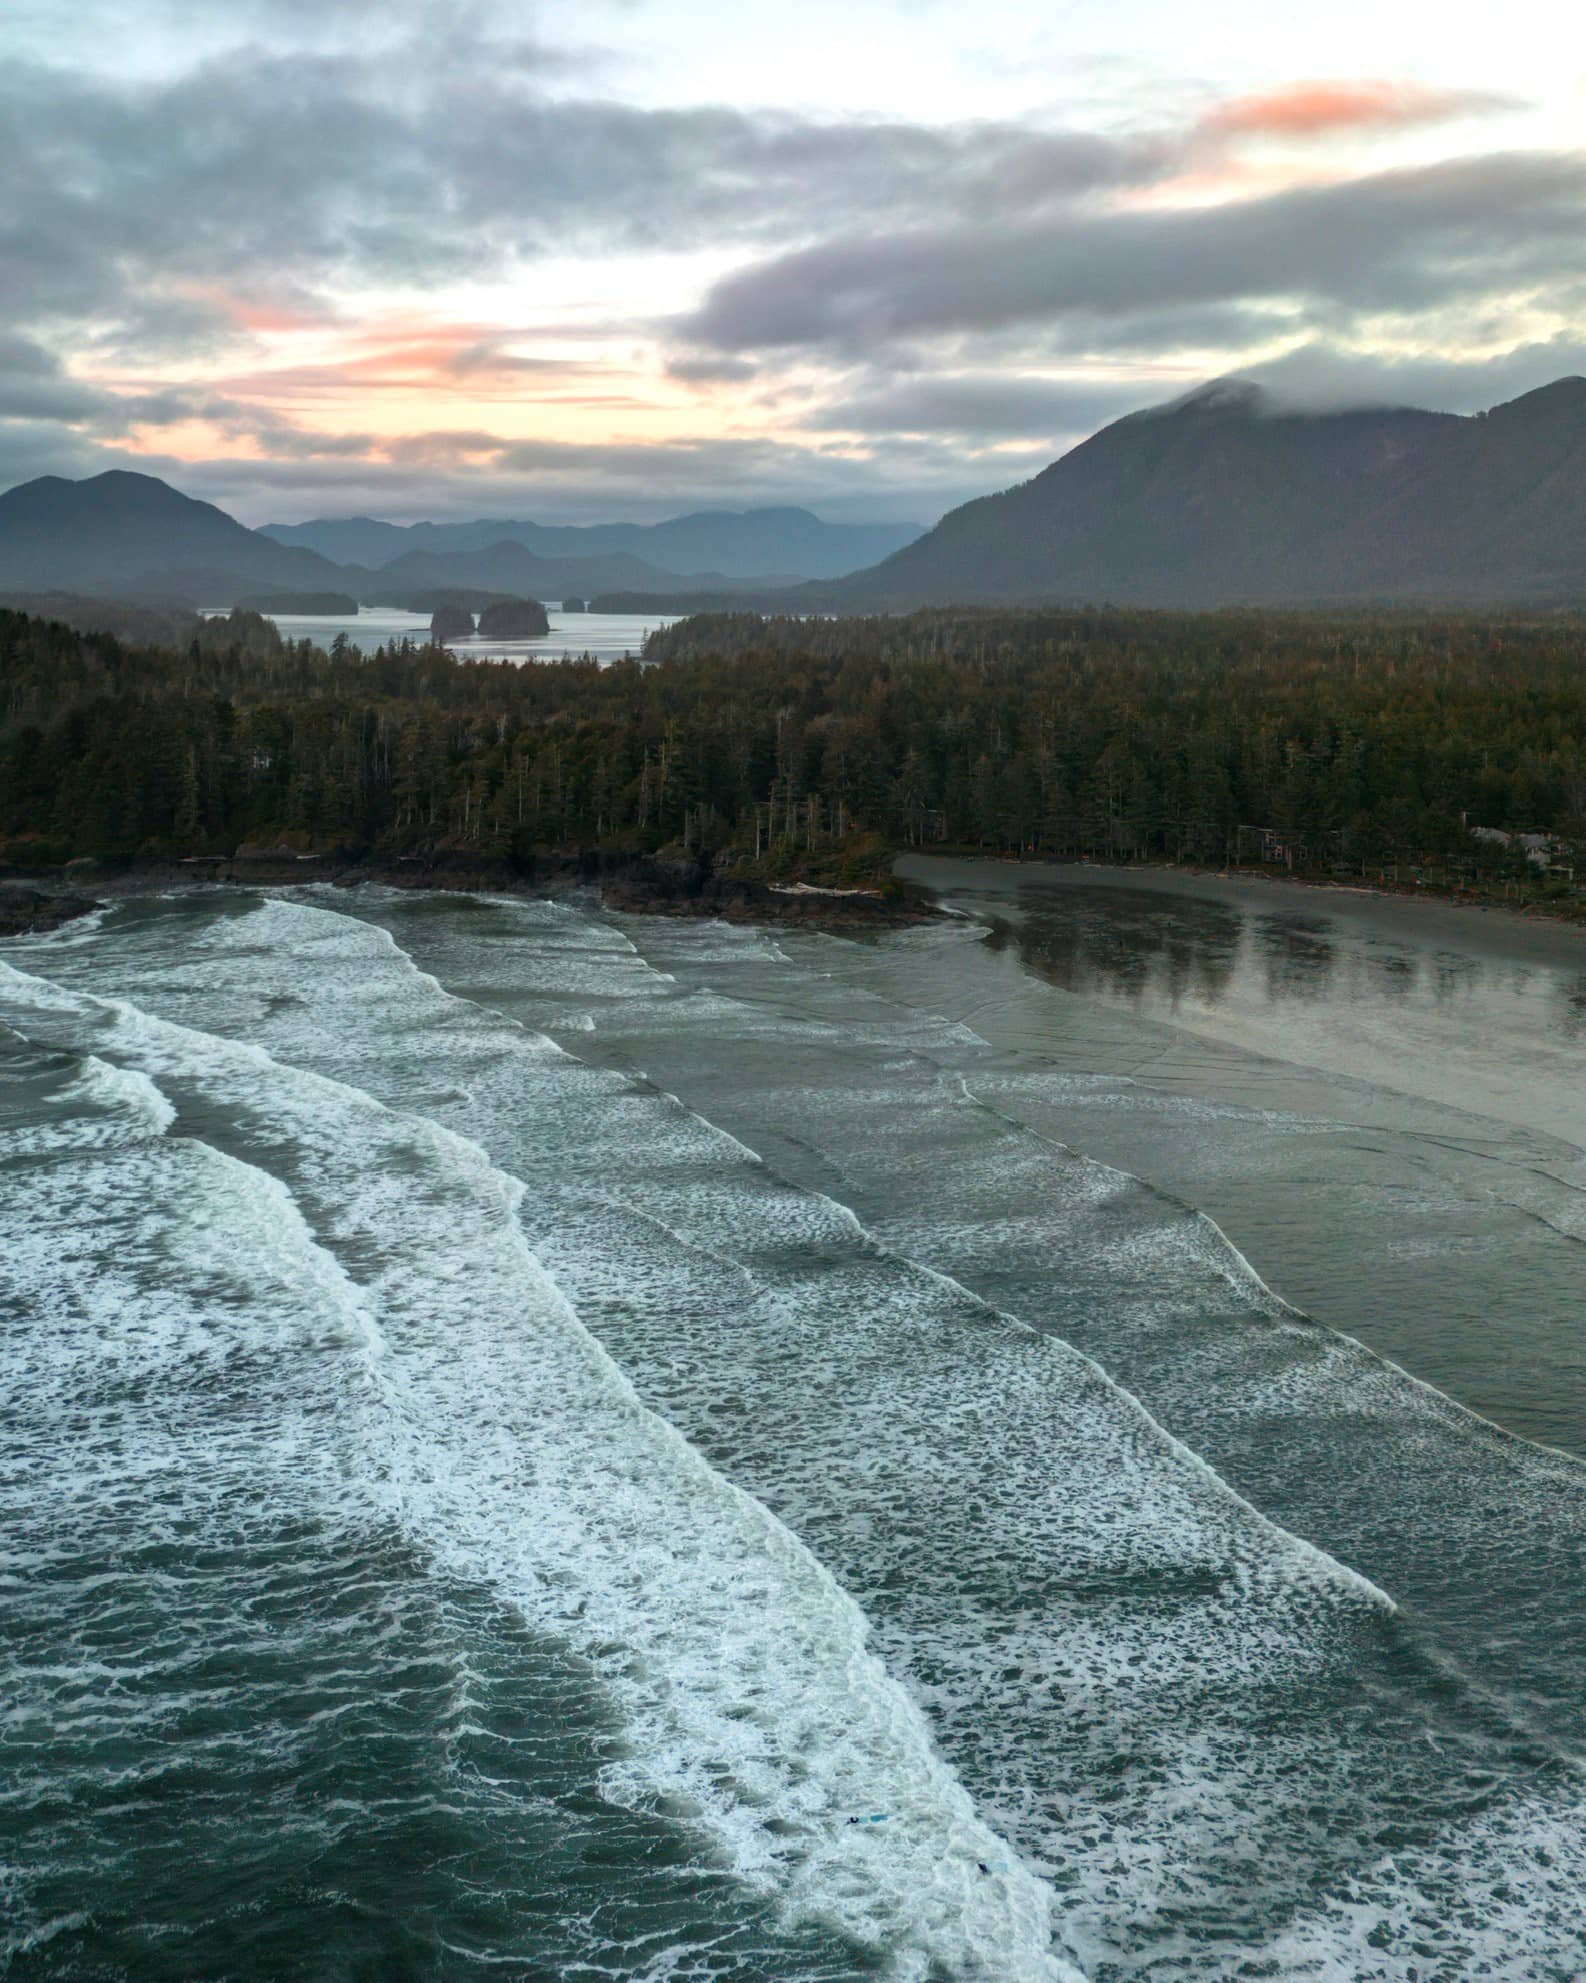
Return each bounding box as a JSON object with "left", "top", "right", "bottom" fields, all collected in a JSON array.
[{"left": 0, "top": 468, "right": 912, "bottom": 607}]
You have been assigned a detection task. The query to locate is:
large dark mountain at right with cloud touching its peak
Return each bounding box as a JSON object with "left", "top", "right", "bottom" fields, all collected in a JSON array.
[{"left": 828, "top": 379, "right": 1586, "bottom": 611}]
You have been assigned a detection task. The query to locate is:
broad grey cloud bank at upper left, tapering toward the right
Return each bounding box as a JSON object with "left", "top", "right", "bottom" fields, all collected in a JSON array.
[{"left": 0, "top": 36, "right": 1160, "bottom": 350}]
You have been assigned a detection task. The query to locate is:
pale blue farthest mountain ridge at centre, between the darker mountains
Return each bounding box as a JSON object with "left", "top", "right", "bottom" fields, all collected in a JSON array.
[{"left": 264, "top": 508, "right": 922, "bottom": 585}]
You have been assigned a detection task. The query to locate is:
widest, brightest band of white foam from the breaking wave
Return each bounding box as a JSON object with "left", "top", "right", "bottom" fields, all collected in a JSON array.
[{"left": 0, "top": 943, "right": 1073, "bottom": 1983}]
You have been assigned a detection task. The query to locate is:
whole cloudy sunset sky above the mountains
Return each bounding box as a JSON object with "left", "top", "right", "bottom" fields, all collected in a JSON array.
[{"left": 0, "top": 0, "right": 1586, "bottom": 524}]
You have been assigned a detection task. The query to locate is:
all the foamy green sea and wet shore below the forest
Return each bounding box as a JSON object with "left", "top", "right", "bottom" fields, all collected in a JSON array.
[{"left": 0, "top": 863, "right": 1586, "bottom": 1983}]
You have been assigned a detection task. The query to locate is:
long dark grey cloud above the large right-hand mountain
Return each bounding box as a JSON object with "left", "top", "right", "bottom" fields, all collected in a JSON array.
[{"left": 680, "top": 153, "right": 1586, "bottom": 353}]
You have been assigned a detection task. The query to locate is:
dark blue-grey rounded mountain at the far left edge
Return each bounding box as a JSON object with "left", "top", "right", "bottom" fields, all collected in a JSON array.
[{"left": 0, "top": 468, "right": 341, "bottom": 605}]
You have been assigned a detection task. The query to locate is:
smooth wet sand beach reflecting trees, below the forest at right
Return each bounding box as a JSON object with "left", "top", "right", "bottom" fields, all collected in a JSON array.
[{"left": 898, "top": 855, "right": 1586, "bottom": 1148}]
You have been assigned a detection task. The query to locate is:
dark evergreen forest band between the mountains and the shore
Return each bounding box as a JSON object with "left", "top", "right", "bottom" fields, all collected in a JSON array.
[{"left": 0, "top": 594, "right": 1586, "bottom": 886}]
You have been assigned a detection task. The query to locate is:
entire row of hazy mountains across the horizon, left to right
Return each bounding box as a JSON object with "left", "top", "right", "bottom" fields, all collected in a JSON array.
[{"left": 0, "top": 379, "right": 1586, "bottom": 613}]
